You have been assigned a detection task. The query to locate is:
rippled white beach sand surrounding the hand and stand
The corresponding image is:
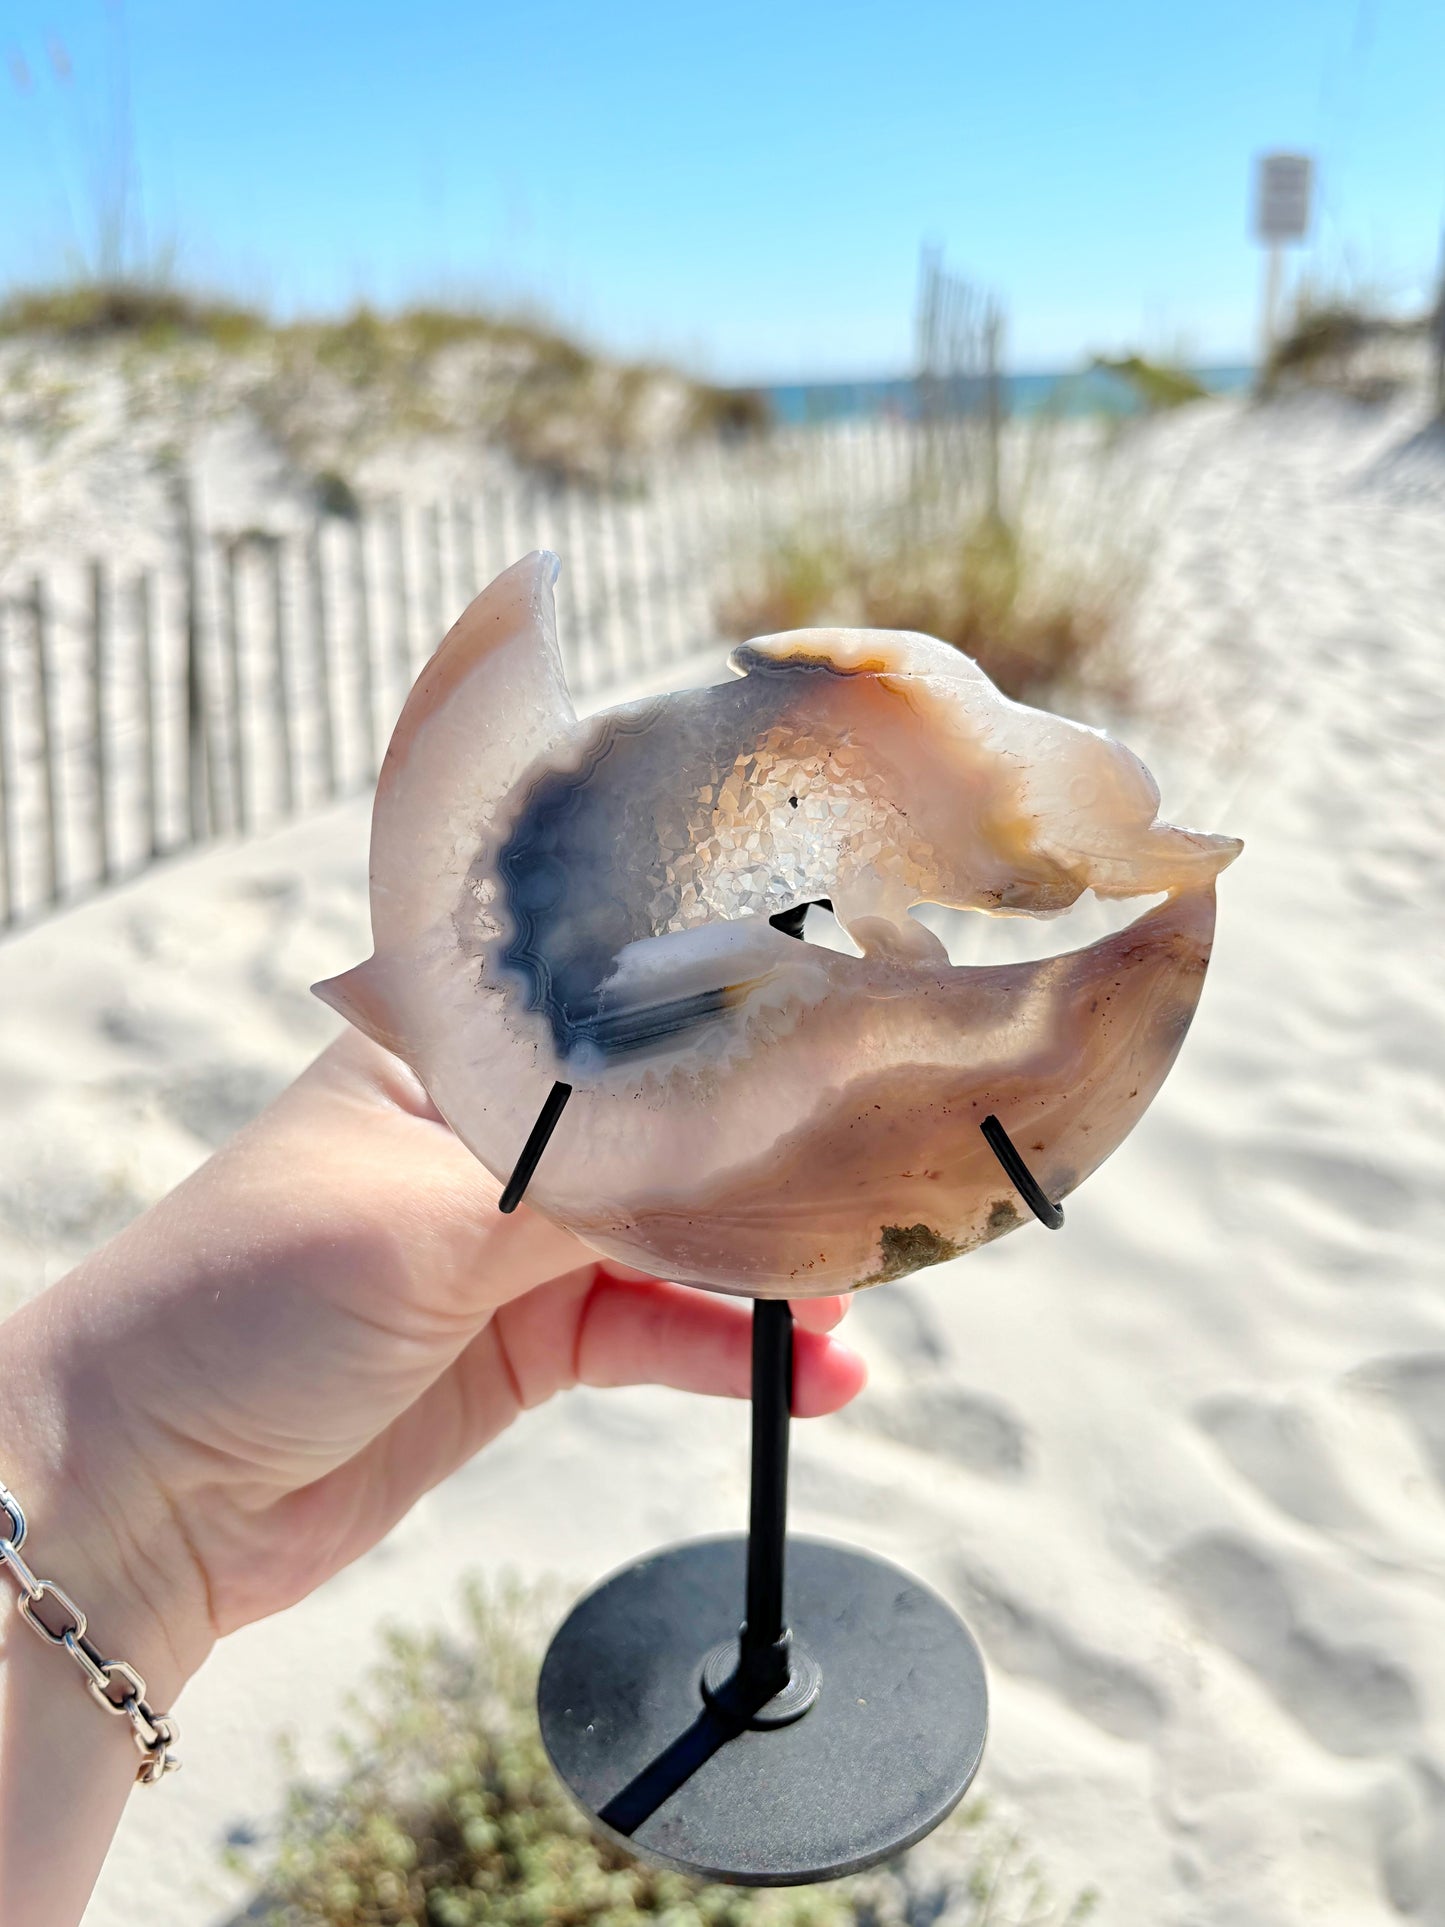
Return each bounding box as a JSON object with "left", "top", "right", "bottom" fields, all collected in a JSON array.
[{"left": 0, "top": 401, "right": 1445, "bottom": 1927}]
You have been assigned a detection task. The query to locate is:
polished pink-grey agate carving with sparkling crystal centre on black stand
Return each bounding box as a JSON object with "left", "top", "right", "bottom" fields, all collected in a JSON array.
[{"left": 318, "top": 553, "right": 1239, "bottom": 1297}]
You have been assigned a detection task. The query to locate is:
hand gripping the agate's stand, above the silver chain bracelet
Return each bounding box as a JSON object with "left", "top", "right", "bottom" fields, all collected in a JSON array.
[{"left": 0, "top": 1033, "right": 863, "bottom": 1705}]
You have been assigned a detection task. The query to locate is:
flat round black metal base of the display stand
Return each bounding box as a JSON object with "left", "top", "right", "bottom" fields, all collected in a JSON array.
[{"left": 538, "top": 1538, "right": 988, "bottom": 1887}]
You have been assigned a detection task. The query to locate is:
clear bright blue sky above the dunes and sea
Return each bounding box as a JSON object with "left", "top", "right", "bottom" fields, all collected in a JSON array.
[{"left": 0, "top": 0, "right": 1445, "bottom": 380}]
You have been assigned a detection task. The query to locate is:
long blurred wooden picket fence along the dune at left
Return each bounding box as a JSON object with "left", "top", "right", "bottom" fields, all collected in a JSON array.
[{"left": 0, "top": 418, "right": 919, "bottom": 929}]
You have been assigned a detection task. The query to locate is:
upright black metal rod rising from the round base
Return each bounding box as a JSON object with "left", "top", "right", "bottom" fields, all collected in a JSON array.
[{"left": 742, "top": 1299, "right": 792, "bottom": 1682}]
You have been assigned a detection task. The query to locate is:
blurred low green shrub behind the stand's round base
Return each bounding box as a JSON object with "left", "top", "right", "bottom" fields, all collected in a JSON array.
[{"left": 231, "top": 1586, "right": 1092, "bottom": 1927}]
